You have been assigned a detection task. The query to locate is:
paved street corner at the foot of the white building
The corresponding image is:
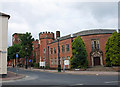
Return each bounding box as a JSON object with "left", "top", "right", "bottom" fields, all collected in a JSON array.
[{"left": 1, "top": 71, "right": 26, "bottom": 82}]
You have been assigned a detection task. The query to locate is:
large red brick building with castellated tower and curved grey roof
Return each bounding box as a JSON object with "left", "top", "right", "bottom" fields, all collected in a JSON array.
[{"left": 13, "top": 29, "right": 115, "bottom": 69}]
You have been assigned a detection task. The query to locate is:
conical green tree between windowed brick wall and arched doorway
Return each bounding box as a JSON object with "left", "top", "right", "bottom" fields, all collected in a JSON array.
[{"left": 70, "top": 36, "right": 88, "bottom": 68}]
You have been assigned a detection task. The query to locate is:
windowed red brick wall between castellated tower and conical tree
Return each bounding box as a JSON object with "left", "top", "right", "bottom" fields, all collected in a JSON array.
[{"left": 48, "top": 38, "right": 72, "bottom": 68}]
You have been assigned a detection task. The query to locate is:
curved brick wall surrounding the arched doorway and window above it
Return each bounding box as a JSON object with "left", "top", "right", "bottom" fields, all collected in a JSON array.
[{"left": 81, "top": 34, "right": 112, "bottom": 66}]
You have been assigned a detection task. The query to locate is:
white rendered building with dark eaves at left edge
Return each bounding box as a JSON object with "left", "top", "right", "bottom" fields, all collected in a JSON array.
[{"left": 0, "top": 12, "right": 10, "bottom": 77}]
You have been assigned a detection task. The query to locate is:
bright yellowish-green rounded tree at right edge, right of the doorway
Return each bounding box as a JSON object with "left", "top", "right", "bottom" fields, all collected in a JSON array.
[{"left": 105, "top": 32, "right": 120, "bottom": 66}]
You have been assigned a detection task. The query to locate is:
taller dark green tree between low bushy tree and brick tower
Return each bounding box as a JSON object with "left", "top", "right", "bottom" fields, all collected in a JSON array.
[{"left": 19, "top": 32, "right": 34, "bottom": 58}]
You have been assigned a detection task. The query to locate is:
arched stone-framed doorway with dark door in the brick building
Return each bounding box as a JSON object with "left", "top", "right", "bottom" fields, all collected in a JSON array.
[{"left": 91, "top": 51, "right": 103, "bottom": 66}]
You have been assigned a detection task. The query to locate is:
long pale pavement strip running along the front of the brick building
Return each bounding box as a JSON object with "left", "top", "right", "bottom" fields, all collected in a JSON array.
[{"left": 19, "top": 68, "right": 120, "bottom": 75}]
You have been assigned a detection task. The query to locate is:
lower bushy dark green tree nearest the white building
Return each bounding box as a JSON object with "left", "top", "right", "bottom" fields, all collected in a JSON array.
[{"left": 7, "top": 44, "right": 21, "bottom": 60}]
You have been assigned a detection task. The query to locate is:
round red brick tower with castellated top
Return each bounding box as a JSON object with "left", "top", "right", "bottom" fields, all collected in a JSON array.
[{"left": 39, "top": 32, "right": 54, "bottom": 66}]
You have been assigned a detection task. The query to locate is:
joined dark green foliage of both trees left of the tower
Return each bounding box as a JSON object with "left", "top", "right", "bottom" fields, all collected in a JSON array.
[{"left": 8, "top": 32, "right": 34, "bottom": 60}]
